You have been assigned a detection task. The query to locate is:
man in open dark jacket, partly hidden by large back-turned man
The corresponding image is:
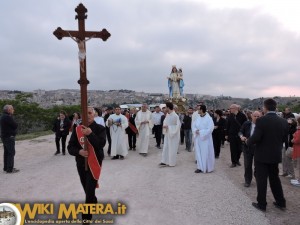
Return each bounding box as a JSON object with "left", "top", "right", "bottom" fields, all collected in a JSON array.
[{"left": 239, "top": 111, "right": 261, "bottom": 187}]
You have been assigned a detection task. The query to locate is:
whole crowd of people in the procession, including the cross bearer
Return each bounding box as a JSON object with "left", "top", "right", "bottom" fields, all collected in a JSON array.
[{"left": 0, "top": 99, "right": 300, "bottom": 219}]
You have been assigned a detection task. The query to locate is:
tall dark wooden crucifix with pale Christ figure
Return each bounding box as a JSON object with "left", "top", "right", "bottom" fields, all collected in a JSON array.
[{"left": 53, "top": 3, "right": 110, "bottom": 169}]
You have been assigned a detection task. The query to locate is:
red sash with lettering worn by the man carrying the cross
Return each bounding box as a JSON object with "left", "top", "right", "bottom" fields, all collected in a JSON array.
[{"left": 76, "top": 125, "right": 101, "bottom": 188}]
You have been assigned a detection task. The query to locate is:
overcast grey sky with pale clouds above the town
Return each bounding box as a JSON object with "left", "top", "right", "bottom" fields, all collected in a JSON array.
[{"left": 0, "top": 0, "right": 300, "bottom": 99}]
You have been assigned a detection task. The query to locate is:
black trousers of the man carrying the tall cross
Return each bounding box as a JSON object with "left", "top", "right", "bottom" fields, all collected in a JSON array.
[{"left": 77, "top": 165, "right": 97, "bottom": 220}]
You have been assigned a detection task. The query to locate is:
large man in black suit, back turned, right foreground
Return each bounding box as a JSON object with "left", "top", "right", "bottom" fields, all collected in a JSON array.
[{"left": 246, "top": 99, "right": 289, "bottom": 211}]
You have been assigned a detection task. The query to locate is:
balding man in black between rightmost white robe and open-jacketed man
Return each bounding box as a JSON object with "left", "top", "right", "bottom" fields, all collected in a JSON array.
[{"left": 226, "top": 104, "right": 247, "bottom": 168}]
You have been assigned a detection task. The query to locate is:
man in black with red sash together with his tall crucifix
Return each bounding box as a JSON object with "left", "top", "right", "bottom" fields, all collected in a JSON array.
[{"left": 53, "top": 3, "right": 110, "bottom": 224}]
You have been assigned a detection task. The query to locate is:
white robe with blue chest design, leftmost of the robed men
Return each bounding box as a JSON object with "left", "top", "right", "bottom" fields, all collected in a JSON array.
[{"left": 106, "top": 114, "right": 128, "bottom": 156}]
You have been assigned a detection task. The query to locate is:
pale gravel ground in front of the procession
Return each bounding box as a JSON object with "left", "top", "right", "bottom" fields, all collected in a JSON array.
[{"left": 0, "top": 135, "right": 300, "bottom": 225}]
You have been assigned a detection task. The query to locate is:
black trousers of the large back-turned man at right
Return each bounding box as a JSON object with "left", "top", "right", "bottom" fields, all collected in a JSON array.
[{"left": 254, "top": 161, "right": 286, "bottom": 208}]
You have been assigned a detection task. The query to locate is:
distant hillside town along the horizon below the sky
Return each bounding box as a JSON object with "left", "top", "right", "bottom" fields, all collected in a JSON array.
[{"left": 0, "top": 89, "right": 300, "bottom": 112}]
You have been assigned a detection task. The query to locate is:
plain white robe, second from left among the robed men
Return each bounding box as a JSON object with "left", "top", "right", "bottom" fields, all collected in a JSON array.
[{"left": 135, "top": 110, "right": 153, "bottom": 153}]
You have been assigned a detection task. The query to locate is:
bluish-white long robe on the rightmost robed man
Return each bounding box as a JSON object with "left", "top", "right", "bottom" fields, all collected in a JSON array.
[{"left": 192, "top": 113, "right": 215, "bottom": 173}]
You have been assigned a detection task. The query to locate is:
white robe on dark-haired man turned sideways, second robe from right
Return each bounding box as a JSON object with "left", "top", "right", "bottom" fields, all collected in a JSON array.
[{"left": 161, "top": 112, "right": 181, "bottom": 166}]
